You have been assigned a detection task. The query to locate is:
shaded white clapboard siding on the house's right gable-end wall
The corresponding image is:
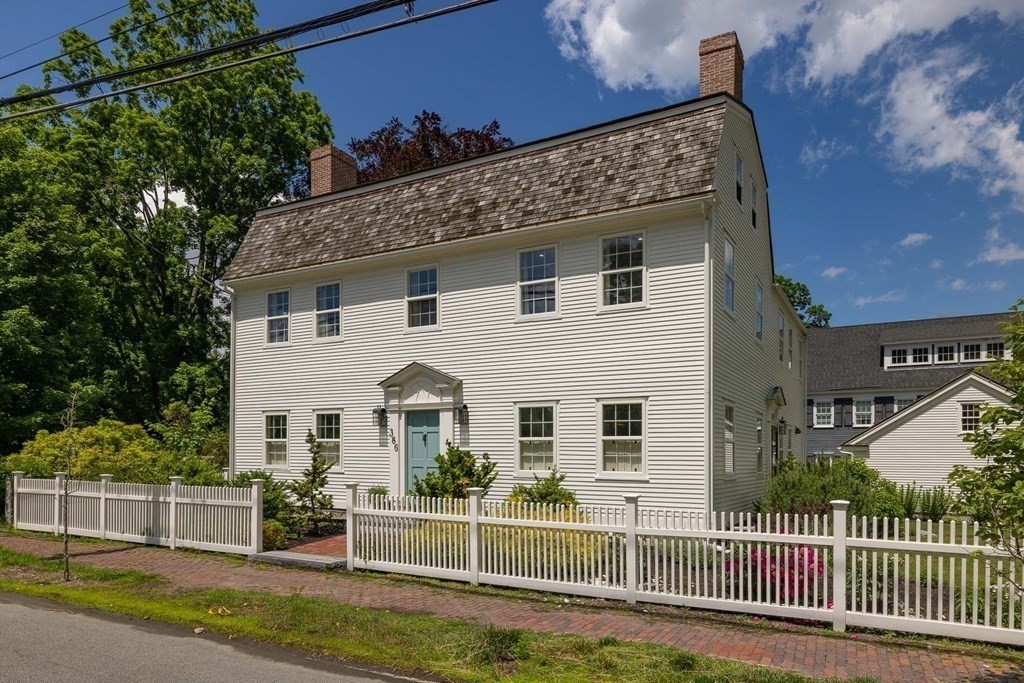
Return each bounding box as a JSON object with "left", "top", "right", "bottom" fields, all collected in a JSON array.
[{"left": 712, "top": 106, "right": 807, "bottom": 511}]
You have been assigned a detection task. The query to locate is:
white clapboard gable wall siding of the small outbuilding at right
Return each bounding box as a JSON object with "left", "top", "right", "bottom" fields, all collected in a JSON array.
[{"left": 865, "top": 384, "right": 1006, "bottom": 486}]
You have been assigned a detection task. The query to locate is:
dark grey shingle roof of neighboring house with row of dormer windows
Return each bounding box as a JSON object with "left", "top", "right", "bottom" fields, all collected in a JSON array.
[{"left": 807, "top": 313, "right": 1012, "bottom": 394}]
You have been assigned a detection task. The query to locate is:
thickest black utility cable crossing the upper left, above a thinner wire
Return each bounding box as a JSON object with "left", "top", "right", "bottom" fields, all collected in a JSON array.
[{"left": 0, "top": 0, "right": 408, "bottom": 106}]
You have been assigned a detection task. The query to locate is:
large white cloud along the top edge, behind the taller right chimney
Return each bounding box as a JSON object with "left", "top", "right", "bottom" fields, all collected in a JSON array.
[{"left": 545, "top": 0, "right": 1024, "bottom": 93}]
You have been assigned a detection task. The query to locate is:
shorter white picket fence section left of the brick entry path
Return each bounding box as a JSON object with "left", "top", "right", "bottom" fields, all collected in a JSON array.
[{"left": 11, "top": 472, "right": 263, "bottom": 555}]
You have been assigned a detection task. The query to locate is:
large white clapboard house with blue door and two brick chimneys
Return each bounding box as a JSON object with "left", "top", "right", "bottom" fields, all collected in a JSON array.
[{"left": 224, "top": 34, "right": 806, "bottom": 510}]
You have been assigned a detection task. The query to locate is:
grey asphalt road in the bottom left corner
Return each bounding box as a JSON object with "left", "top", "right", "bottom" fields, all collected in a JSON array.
[{"left": 0, "top": 593, "right": 425, "bottom": 683}]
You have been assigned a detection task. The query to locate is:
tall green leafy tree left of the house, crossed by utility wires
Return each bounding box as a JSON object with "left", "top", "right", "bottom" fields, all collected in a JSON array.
[{"left": 11, "top": 0, "right": 331, "bottom": 438}]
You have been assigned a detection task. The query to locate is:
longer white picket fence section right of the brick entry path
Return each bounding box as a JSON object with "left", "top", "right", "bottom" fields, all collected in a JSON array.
[{"left": 346, "top": 484, "right": 1024, "bottom": 645}]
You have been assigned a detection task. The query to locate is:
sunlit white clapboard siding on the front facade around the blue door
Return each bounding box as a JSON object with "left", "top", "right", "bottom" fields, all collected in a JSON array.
[{"left": 233, "top": 206, "right": 708, "bottom": 509}]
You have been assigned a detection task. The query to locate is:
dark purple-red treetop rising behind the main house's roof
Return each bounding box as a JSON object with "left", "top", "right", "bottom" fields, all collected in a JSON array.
[{"left": 348, "top": 110, "right": 513, "bottom": 183}]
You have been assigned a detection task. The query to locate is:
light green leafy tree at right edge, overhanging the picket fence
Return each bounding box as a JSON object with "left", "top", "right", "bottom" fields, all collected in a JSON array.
[{"left": 949, "top": 299, "right": 1024, "bottom": 590}]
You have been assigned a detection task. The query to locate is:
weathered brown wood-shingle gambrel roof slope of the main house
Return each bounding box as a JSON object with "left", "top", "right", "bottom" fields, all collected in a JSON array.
[{"left": 224, "top": 99, "right": 726, "bottom": 281}]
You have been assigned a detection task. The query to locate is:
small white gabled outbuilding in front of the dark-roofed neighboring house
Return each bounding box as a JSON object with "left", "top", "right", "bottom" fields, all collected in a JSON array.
[{"left": 843, "top": 371, "right": 1013, "bottom": 487}]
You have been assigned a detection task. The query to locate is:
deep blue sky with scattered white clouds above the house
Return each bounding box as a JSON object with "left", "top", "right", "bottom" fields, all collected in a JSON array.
[{"left": 0, "top": 0, "right": 1024, "bottom": 325}]
